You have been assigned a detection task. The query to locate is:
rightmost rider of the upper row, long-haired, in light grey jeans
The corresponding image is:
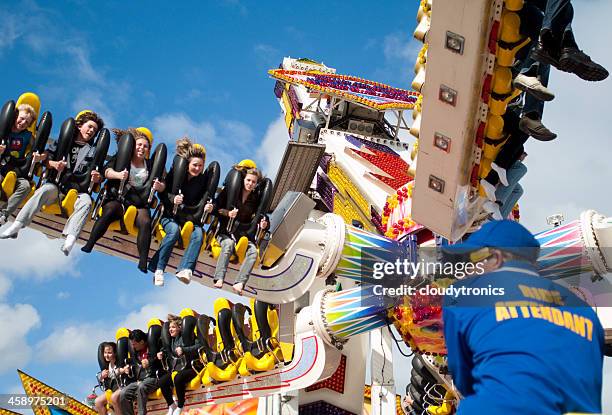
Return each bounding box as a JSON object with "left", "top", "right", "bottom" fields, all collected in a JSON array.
[{"left": 213, "top": 166, "right": 268, "bottom": 295}]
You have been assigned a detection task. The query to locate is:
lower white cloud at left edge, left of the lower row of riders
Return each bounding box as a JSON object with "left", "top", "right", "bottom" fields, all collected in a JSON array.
[{"left": 0, "top": 304, "right": 40, "bottom": 373}]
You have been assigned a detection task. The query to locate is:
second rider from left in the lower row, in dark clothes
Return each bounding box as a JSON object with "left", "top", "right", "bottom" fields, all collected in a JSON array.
[{"left": 118, "top": 329, "right": 161, "bottom": 415}]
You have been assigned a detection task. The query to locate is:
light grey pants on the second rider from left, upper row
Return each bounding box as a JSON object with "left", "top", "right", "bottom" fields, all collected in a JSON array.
[{"left": 16, "top": 183, "right": 91, "bottom": 237}]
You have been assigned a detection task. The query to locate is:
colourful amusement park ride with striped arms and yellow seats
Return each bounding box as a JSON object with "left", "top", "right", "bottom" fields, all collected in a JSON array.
[{"left": 3, "top": 0, "right": 612, "bottom": 415}]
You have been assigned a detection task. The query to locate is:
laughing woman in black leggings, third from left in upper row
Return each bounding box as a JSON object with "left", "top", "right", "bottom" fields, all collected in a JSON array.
[{"left": 81, "top": 127, "right": 165, "bottom": 274}]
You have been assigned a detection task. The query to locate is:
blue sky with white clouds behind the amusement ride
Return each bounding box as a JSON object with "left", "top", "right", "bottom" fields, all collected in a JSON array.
[{"left": 0, "top": 0, "right": 612, "bottom": 410}]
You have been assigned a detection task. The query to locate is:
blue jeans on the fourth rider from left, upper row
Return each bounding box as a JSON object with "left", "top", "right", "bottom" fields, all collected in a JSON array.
[{"left": 149, "top": 218, "right": 203, "bottom": 272}]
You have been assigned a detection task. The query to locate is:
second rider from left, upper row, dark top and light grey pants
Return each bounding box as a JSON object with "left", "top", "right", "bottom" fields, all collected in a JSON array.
[{"left": 0, "top": 111, "right": 104, "bottom": 255}]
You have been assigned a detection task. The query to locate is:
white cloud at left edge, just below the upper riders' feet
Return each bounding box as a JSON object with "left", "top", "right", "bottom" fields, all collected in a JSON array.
[{"left": 0, "top": 228, "right": 78, "bottom": 280}]
